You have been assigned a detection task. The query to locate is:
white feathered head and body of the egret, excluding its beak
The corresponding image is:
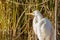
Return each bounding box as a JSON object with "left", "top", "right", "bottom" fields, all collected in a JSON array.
[{"left": 33, "top": 10, "right": 54, "bottom": 40}]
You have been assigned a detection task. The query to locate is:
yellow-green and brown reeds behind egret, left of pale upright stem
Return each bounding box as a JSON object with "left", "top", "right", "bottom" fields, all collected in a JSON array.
[{"left": 0, "top": 0, "right": 55, "bottom": 40}]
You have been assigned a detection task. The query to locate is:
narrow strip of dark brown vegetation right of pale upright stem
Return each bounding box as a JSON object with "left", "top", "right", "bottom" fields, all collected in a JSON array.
[{"left": 56, "top": 0, "right": 60, "bottom": 40}]
